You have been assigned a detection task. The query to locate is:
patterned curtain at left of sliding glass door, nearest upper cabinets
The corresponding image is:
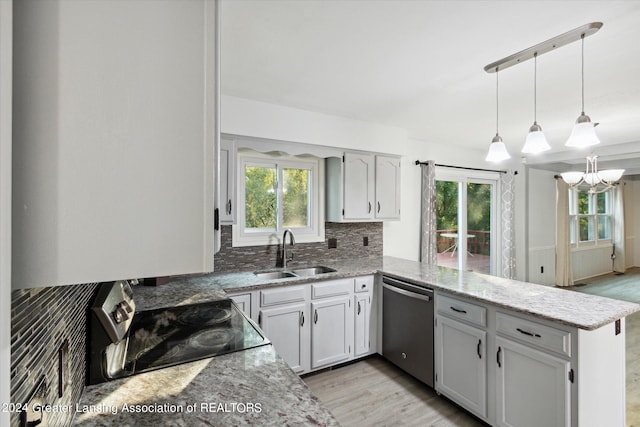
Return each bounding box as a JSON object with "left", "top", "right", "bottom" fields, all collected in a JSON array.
[{"left": 420, "top": 160, "right": 438, "bottom": 265}]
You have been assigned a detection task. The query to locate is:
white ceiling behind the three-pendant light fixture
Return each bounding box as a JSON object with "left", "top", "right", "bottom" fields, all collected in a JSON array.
[{"left": 221, "top": 0, "right": 640, "bottom": 174}]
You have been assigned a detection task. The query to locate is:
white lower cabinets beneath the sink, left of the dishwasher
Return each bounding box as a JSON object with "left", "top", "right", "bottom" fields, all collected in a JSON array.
[{"left": 240, "top": 276, "right": 378, "bottom": 374}]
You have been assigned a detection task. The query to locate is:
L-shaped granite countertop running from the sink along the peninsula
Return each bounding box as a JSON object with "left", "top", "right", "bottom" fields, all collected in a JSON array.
[{"left": 134, "top": 256, "right": 640, "bottom": 330}]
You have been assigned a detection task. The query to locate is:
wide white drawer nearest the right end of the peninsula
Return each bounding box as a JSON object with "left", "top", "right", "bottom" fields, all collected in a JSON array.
[{"left": 496, "top": 312, "right": 571, "bottom": 357}]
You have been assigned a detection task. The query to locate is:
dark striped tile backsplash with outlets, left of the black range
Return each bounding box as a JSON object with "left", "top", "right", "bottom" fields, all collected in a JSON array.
[{"left": 11, "top": 284, "right": 97, "bottom": 426}]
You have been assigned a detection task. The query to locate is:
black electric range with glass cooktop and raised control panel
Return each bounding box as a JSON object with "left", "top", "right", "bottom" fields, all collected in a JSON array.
[{"left": 88, "top": 281, "right": 270, "bottom": 384}]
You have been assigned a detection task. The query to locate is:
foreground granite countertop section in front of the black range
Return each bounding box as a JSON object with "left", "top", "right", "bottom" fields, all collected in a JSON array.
[{"left": 73, "top": 345, "right": 339, "bottom": 427}]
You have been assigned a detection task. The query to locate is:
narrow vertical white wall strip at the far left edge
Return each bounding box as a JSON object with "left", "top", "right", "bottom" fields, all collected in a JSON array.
[{"left": 0, "top": 0, "right": 13, "bottom": 426}]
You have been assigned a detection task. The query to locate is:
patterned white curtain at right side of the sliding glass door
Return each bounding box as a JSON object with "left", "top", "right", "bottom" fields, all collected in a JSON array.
[{"left": 500, "top": 171, "right": 516, "bottom": 279}]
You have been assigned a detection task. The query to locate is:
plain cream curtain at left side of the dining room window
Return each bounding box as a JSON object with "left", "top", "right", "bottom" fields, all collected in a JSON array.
[{"left": 556, "top": 179, "right": 575, "bottom": 286}]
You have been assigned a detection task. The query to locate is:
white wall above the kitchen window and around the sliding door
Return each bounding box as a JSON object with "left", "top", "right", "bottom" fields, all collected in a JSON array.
[{"left": 221, "top": 95, "right": 524, "bottom": 280}]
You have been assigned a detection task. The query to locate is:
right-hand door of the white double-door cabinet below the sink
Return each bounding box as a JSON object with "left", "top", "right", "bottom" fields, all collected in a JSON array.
[{"left": 311, "top": 296, "right": 353, "bottom": 369}]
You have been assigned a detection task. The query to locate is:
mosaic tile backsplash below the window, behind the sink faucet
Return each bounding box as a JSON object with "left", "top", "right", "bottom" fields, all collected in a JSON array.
[{"left": 214, "top": 222, "right": 382, "bottom": 273}]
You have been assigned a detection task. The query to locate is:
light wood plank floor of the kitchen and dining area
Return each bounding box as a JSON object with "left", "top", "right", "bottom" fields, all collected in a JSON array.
[{"left": 303, "top": 268, "right": 640, "bottom": 427}]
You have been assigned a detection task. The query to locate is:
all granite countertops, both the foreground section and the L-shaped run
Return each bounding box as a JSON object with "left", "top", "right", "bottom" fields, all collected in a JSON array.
[{"left": 74, "top": 257, "right": 640, "bottom": 426}]
